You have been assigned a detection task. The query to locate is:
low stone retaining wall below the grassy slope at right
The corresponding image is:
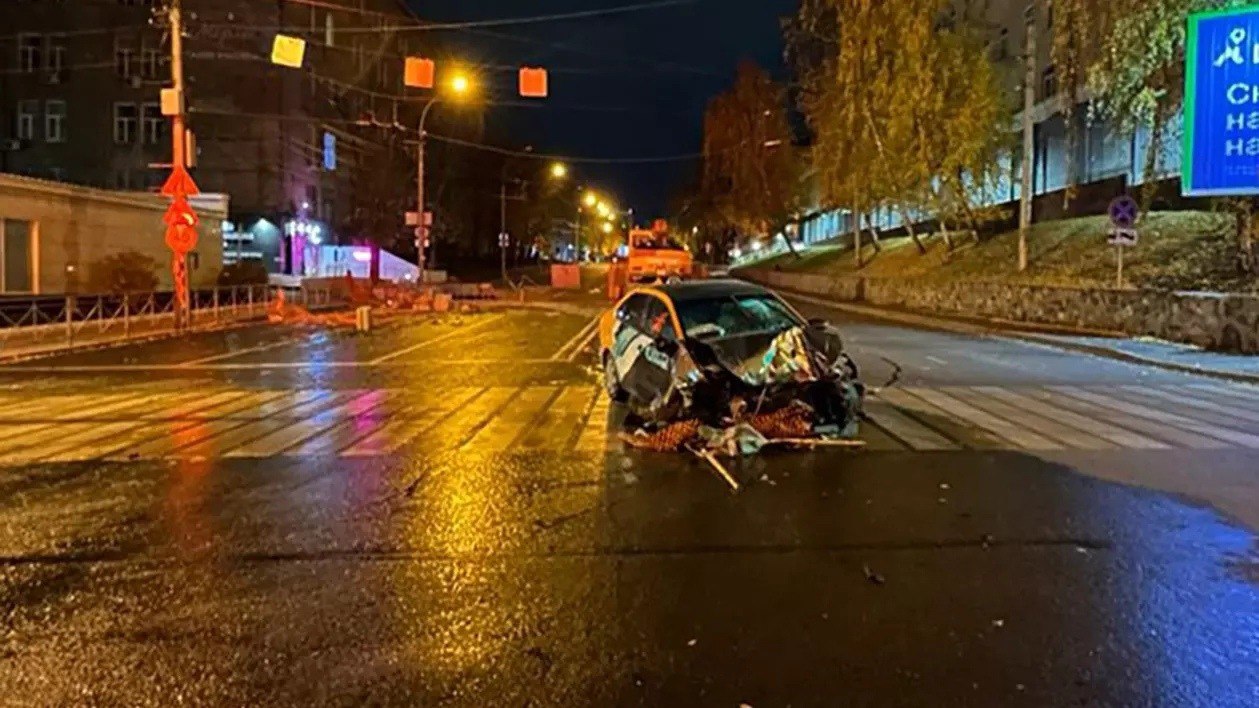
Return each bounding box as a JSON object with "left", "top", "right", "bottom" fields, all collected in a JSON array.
[{"left": 743, "top": 270, "right": 1259, "bottom": 354}]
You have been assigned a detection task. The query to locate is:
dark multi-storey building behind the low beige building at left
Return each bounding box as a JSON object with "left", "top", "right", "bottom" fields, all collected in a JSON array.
[{"left": 0, "top": 0, "right": 424, "bottom": 265}]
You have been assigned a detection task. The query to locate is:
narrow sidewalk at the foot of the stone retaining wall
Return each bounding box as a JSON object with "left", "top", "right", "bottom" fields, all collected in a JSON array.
[{"left": 784, "top": 291, "right": 1259, "bottom": 383}]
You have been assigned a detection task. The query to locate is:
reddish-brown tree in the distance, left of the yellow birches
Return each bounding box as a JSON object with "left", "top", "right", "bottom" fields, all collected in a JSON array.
[{"left": 695, "top": 62, "right": 801, "bottom": 253}]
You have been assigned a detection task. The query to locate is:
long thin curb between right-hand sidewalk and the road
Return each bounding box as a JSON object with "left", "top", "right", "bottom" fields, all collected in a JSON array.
[{"left": 783, "top": 288, "right": 1259, "bottom": 384}]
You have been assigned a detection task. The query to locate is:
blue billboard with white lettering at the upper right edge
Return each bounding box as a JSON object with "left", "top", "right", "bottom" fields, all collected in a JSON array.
[{"left": 1181, "top": 5, "right": 1259, "bottom": 197}]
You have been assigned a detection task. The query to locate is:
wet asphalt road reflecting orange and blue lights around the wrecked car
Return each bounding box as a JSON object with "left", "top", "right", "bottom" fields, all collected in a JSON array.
[{"left": 0, "top": 297, "right": 1259, "bottom": 708}]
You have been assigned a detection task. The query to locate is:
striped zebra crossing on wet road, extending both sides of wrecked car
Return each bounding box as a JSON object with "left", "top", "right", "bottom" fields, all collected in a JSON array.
[{"left": 0, "top": 383, "right": 1259, "bottom": 465}]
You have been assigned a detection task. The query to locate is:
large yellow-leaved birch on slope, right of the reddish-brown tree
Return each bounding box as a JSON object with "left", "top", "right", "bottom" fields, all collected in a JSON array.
[{"left": 787, "top": 0, "right": 1008, "bottom": 266}]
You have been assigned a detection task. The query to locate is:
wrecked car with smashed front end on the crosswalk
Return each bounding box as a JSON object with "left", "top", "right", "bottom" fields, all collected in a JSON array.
[{"left": 599, "top": 280, "right": 865, "bottom": 448}]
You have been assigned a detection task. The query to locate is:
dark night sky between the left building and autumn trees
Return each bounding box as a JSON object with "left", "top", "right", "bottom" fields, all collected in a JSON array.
[{"left": 409, "top": 0, "right": 796, "bottom": 220}]
